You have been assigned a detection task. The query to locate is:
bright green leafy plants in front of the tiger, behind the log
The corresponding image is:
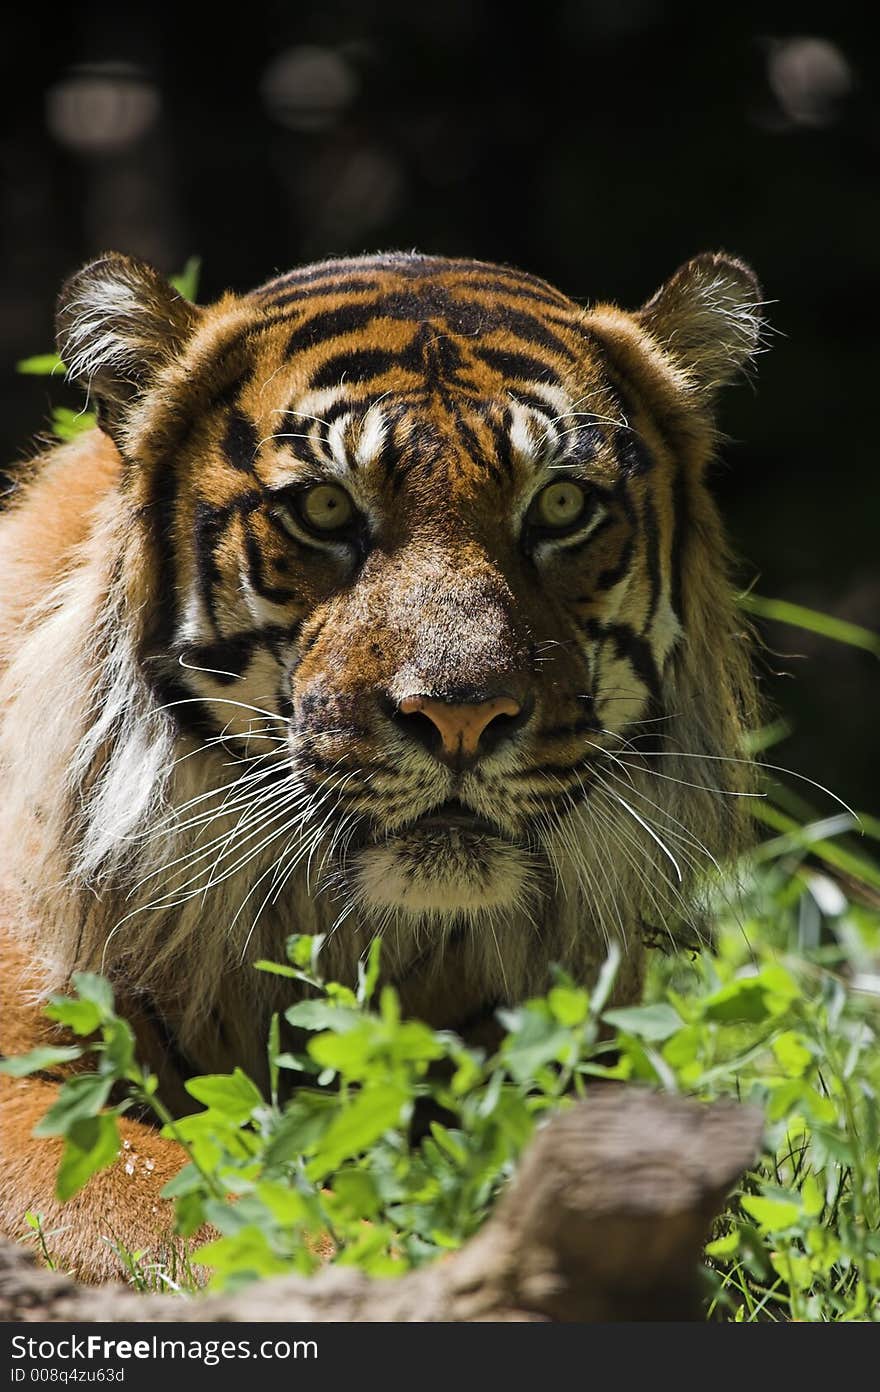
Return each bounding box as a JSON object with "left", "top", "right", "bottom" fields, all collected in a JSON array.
[{"left": 4, "top": 825, "right": 880, "bottom": 1320}]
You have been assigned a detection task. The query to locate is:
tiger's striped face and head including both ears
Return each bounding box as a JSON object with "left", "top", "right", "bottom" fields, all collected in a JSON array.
[{"left": 60, "top": 255, "right": 757, "bottom": 1013}]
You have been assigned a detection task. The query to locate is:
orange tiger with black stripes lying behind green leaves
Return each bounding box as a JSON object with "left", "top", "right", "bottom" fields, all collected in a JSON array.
[{"left": 0, "top": 244, "right": 762, "bottom": 1281}]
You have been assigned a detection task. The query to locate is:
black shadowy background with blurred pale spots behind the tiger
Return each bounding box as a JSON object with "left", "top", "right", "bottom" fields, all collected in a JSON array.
[{"left": 0, "top": 0, "right": 880, "bottom": 812}]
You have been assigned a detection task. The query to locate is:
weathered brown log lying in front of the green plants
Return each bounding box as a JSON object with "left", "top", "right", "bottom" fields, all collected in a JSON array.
[{"left": 0, "top": 1087, "right": 763, "bottom": 1324}]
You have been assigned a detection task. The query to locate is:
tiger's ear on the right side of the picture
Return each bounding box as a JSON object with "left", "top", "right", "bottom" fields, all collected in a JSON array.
[{"left": 634, "top": 252, "right": 763, "bottom": 397}]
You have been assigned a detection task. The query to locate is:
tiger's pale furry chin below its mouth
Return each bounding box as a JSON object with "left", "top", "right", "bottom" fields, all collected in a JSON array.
[{"left": 351, "top": 827, "right": 536, "bottom": 919}]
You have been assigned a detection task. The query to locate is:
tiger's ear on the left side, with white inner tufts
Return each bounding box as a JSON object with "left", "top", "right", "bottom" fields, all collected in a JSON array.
[{"left": 56, "top": 252, "right": 201, "bottom": 434}]
